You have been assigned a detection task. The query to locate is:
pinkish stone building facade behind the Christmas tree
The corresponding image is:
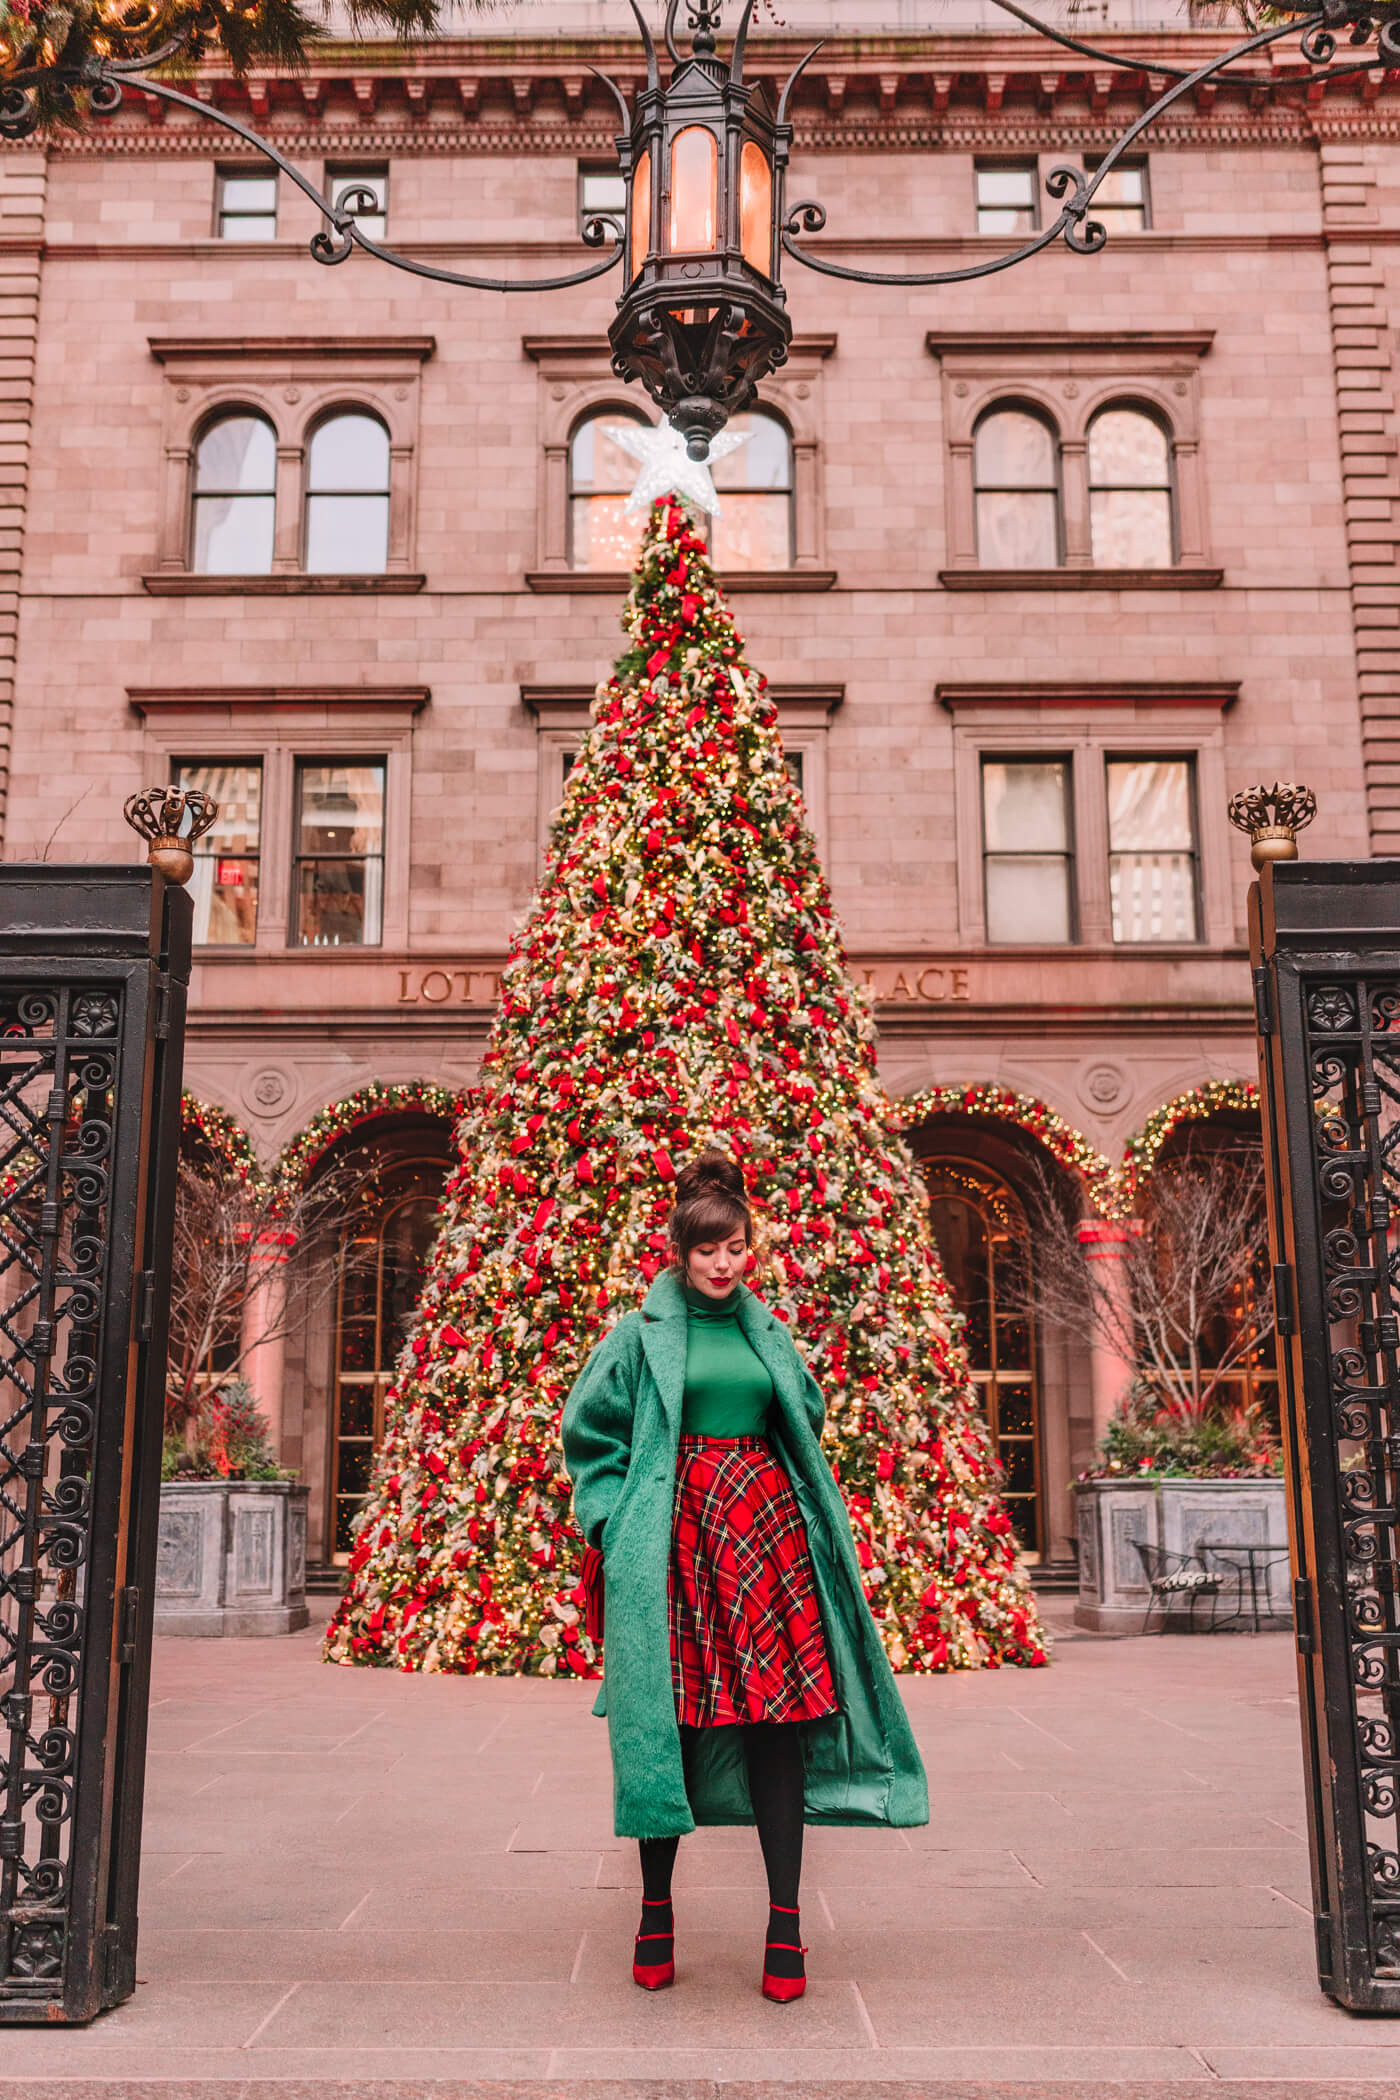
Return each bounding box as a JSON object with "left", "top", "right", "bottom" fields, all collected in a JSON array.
[{"left": 0, "top": 4, "right": 1400, "bottom": 1560}]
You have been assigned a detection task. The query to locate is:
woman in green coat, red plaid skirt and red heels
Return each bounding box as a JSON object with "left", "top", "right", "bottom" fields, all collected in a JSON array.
[{"left": 563, "top": 1151, "right": 928, "bottom": 2003}]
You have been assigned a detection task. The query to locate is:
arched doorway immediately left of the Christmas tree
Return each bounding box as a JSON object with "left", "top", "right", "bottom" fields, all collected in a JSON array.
[{"left": 330, "top": 1159, "right": 443, "bottom": 1562}]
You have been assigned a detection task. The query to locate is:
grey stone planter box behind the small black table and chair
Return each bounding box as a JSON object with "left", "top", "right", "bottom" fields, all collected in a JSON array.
[{"left": 1075, "top": 1476, "right": 1293, "bottom": 1634}]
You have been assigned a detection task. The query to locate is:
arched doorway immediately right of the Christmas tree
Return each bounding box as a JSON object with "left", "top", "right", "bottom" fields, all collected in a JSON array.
[{"left": 924, "top": 1157, "right": 1045, "bottom": 1558}]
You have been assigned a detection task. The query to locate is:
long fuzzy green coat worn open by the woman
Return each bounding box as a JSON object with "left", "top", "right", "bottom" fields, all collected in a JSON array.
[{"left": 563, "top": 1271, "right": 928, "bottom": 1838}]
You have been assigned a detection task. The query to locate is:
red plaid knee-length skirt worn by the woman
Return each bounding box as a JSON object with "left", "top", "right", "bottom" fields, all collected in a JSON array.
[{"left": 670, "top": 1436, "right": 837, "bottom": 1728}]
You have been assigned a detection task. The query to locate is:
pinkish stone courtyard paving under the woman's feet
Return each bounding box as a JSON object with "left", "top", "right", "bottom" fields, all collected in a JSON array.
[{"left": 0, "top": 1595, "right": 1400, "bottom": 2100}]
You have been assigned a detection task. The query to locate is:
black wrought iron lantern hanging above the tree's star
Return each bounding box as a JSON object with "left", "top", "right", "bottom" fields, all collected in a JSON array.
[{"left": 609, "top": 0, "right": 810, "bottom": 460}]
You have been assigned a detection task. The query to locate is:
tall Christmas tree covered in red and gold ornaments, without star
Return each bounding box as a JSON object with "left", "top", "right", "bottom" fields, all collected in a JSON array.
[{"left": 327, "top": 498, "right": 1045, "bottom": 1676}]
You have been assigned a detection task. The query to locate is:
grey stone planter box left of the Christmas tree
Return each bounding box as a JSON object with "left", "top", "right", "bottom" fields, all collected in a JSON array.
[{"left": 155, "top": 1481, "right": 311, "bottom": 1636}]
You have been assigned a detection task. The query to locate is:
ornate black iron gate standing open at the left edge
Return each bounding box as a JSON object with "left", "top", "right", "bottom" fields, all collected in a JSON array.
[{"left": 0, "top": 867, "right": 191, "bottom": 2022}]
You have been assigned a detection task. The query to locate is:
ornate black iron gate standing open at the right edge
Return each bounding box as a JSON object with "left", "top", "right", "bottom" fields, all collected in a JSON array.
[{"left": 1249, "top": 861, "right": 1400, "bottom": 2012}]
